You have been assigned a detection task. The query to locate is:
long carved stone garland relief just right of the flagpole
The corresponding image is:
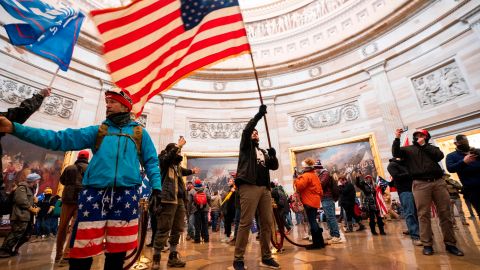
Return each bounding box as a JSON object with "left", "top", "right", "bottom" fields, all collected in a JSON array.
[{"left": 293, "top": 101, "right": 360, "bottom": 132}]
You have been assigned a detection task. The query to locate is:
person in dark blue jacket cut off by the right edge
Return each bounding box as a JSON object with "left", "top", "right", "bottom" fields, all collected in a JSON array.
[{"left": 446, "top": 134, "right": 480, "bottom": 218}]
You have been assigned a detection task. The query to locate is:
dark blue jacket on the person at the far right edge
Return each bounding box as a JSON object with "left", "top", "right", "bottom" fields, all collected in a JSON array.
[{"left": 446, "top": 150, "right": 480, "bottom": 188}]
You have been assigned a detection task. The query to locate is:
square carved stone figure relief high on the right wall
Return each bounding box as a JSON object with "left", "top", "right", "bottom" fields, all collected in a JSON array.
[{"left": 411, "top": 60, "right": 470, "bottom": 109}]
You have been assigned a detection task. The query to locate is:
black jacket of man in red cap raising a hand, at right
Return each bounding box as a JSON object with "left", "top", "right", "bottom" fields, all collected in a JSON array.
[{"left": 392, "top": 138, "right": 443, "bottom": 180}]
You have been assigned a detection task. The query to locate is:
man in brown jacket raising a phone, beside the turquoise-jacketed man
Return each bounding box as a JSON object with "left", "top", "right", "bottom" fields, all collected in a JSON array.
[{"left": 152, "top": 137, "right": 200, "bottom": 269}]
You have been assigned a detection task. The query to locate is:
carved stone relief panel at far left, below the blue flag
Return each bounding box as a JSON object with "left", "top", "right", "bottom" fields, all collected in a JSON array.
[{"left": 0, "top": 76, "right": 77, "bottom": 120}]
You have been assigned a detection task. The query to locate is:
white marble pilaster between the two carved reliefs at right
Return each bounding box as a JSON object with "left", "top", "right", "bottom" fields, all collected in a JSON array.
[{"left": 366, "top": 62, "right": 403, "bottom": 142}]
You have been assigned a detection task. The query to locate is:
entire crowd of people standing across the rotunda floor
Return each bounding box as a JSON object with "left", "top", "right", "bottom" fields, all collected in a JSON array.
[{"left": 0, "top": 89, "right": 480, "bottom": 270}]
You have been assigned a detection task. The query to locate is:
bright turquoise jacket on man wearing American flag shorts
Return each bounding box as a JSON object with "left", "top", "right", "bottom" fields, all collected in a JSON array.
[{"left": 13, "top": 119, "right": 161, "bottom": 190}]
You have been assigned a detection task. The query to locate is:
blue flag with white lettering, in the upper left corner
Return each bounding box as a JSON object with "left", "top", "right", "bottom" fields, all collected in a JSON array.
[{"left": 0, "top": 0, "right": 85, "bottom": 71}]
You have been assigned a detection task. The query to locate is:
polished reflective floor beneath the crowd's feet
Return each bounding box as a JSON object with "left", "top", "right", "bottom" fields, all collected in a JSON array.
[{"left": 0, "top": 219, "right": 480, "bottom": 270}]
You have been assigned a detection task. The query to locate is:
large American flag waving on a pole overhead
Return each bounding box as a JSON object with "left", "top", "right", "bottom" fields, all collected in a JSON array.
[{"left": 91, "top": 0, "right": 250, "bottom": 115}]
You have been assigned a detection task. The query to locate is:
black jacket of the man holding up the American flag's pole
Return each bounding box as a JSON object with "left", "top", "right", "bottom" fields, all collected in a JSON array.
[{"left": 235, "top": 113, "right": 278, "bottom": 188}]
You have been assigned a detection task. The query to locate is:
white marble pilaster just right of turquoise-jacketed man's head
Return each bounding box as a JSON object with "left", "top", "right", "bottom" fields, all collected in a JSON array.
[{"left": 158, "top": 95, "right": 177, "bottom": 152}]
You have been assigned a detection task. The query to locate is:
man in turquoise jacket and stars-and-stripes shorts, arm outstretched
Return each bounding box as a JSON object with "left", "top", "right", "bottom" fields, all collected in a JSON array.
[{"left": 0, "top": 90, "right": 161, "bottom": 270}]
